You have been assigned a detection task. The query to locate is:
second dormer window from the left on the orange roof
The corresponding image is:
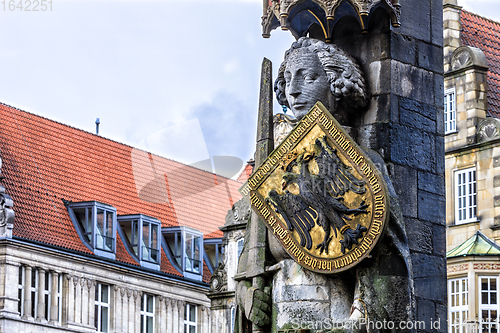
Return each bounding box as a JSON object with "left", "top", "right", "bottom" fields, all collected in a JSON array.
[{"left": 118, "top": 214, "right": 161, "bottom": 269}]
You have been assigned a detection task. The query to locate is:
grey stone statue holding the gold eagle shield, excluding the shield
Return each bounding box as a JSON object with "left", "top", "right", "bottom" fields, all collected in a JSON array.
[{"left": 236, "top": 37, "right": 412, "bottom": 332}]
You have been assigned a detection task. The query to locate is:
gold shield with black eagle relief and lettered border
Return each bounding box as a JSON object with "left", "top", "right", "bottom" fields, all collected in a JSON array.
[{"left": 240, "top": 102, "right": 389, "bottom": 273}]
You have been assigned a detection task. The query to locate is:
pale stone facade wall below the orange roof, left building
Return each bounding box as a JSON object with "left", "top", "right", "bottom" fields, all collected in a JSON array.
[{"left": 0, "top": 240, "right": 210, "bottom": 333}]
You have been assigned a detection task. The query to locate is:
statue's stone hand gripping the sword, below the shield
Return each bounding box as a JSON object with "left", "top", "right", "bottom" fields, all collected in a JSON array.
[{"left": 245, "top": 287, "right": 271, "bottom": 327}]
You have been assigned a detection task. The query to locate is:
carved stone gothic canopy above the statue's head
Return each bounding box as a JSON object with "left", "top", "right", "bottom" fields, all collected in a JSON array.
[{"left": 262, "top": 0, "right": 400, "bottom": 41}]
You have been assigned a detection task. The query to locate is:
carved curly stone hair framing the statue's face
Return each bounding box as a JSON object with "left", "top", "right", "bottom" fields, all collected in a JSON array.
[{"left": 274, "top": 37, "right": 368, "bottom": 111}]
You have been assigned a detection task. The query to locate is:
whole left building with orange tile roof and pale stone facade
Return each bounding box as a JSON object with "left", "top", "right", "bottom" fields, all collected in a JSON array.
[{"left": 0, "top": 104, "right": 241, "bottom": 333}]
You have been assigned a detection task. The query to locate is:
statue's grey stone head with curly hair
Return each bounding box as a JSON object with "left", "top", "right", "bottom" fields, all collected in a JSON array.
[{"left": 274, "top": 37, "right": 368, "bottom": 119}]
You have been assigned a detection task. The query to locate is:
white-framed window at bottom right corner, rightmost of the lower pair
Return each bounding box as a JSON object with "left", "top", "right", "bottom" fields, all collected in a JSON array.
[{"left": 478, "top": 276, "right": 498, "bottom": 333}]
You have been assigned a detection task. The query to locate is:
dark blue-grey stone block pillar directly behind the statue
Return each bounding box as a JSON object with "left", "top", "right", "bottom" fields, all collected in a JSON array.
[{"left": 333, "top": 0, "right": 447, "bottom": 331}]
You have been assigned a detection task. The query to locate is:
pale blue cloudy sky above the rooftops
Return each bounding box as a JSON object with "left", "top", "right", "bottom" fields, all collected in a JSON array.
[{"left": 0, "top": 0, "right": 500, "bottom": 176}]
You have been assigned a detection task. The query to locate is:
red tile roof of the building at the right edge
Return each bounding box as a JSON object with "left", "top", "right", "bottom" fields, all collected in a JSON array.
[{"left": 460, "top": 10, "right": 500, "bottom": 118}]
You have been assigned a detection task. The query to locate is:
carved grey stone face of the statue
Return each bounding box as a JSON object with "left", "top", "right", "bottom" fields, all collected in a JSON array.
[{"left": 284, "top": 49, "right": 334, "bottom": 119}]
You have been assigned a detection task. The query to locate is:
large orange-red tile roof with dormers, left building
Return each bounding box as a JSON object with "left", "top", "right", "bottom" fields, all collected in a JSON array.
[{"left": 0, "top": 103, "right": 241, "bottom": 280}]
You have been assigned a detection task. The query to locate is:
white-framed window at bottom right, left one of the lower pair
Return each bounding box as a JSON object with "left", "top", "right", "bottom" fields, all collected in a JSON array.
[{"left": 448, "top": 278, "right": 469, "bottom": 333}]
